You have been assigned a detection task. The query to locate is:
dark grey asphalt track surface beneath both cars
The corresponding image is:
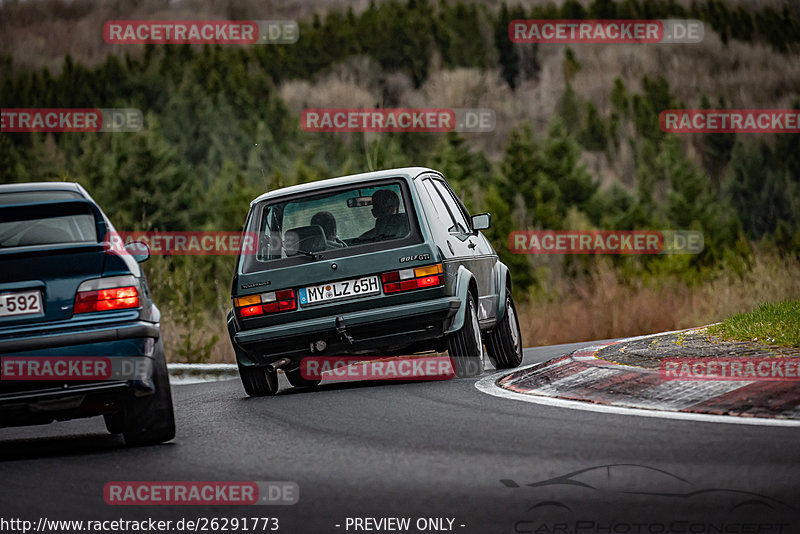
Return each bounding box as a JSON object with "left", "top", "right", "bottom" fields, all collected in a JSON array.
[{"left": 0, "top": 343, "right": 800, "bottom": 534}]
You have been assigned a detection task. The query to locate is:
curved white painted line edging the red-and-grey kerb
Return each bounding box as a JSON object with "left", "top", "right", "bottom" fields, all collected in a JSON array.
[{"left": 475, "top": 367, "right": 800, "bottom": 427}]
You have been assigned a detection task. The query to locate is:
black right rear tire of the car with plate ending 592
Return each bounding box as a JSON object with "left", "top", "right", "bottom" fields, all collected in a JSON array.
[{"left": 121, "top": 339, "right": 175, "bottom": 446}]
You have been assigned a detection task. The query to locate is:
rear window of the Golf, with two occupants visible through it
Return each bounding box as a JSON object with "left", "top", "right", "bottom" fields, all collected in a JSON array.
[{"left": 241, "top": 180, "right": 420, "bottom": 273}]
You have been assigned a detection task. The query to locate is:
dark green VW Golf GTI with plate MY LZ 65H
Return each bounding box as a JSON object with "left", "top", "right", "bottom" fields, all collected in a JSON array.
[{"left": 228, "top": 168, "right": 522, "bottom": 396}]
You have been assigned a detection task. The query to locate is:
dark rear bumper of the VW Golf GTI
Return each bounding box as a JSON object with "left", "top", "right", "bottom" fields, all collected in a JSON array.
[{"left": 228, "top": 297, "right": 461, "bottom": 365}]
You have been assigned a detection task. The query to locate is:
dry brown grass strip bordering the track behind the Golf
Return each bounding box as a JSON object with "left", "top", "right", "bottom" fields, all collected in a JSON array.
[{"left": 162, "top": 256, "right": 800, "bottom": 363}]
